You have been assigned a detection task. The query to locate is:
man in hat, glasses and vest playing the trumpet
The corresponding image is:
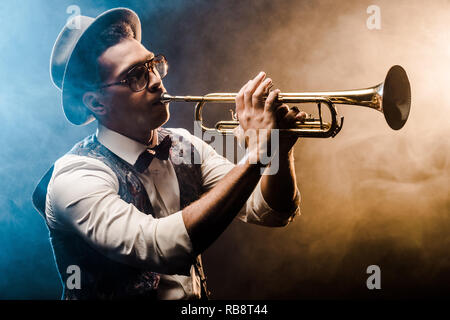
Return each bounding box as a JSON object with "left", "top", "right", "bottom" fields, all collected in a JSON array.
[{"left": 33, "top": 8, "right": 305, "bottom": 299}]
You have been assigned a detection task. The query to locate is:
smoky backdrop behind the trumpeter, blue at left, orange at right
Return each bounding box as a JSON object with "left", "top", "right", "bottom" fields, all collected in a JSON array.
[{"left": 0, "top": 0, "right": 450, "bottom": 299}]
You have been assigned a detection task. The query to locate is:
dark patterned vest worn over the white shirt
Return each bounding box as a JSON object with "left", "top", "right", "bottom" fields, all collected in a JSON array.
[{"left": 33, "top": 129, "right": 208, "bottom": 299}]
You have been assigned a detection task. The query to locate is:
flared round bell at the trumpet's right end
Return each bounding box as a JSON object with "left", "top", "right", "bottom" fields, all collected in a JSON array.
[{"left": 381, "top": 65, "right": 411, "bottom": 130}]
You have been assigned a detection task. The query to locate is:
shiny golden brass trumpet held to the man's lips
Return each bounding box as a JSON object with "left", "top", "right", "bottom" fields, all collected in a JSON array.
[{"left": 161, "top": 65, "right": 411, "bottom": 138}]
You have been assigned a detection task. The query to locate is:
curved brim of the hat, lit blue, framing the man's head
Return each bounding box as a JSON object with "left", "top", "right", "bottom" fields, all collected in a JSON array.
[{"left": 62, "top": 8, "right": 141, "bottom": 125}]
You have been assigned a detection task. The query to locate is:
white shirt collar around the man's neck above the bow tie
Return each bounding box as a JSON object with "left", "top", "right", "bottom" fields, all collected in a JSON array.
[{"left": 96, "top": 124, "right": 158, "bottom": 165}]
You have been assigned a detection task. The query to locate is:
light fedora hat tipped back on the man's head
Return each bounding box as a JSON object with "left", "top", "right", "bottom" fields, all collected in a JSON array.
[{"left": 50, "top": 8, "right": 141, "bottom": 125}]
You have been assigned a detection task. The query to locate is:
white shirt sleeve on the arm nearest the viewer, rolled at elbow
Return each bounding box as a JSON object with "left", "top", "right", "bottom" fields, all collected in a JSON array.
[{"left": 46, "top": 155, "right": 195, "bottom": 274}]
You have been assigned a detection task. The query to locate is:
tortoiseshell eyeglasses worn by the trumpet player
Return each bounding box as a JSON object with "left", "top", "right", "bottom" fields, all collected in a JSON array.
[{"left": 98, "top": 54, "right": 169, "bottom": 92}]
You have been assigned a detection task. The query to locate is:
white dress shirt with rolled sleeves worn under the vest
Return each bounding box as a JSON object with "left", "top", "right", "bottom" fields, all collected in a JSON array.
[{"left": 46, "top": 124, "right": 300, "bottom": 299}]
